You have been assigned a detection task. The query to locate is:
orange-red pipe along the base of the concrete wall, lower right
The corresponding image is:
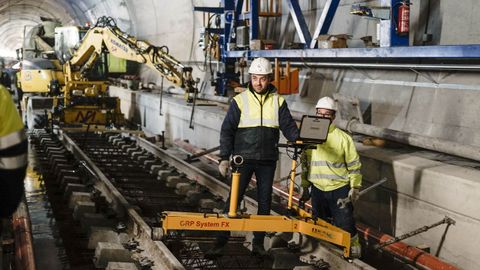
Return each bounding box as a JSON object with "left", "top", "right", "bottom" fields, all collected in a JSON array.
[{"left": 357, "top": 222, "right": 459, "bottom": 270}]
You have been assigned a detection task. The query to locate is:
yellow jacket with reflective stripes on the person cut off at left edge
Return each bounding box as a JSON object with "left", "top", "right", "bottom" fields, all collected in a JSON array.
[{"left": 0, "top": 85, "right": 27, "bottom": 170}]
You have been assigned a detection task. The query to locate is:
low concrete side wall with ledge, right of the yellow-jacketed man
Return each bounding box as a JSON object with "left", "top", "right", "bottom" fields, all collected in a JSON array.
[{"left": 356, "top": 146, "right": 480, "bottom": 269}]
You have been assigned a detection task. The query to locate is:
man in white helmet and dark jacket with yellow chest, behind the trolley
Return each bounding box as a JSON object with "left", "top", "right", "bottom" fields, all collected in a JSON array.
[{"left": 207, "top": 58, "right": 298, "bottom": 257}]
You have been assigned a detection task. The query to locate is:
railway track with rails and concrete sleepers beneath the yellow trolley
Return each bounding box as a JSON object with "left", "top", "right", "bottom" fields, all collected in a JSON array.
[{"left": 30, "top": 129, "right": 462, "bottom": 270}]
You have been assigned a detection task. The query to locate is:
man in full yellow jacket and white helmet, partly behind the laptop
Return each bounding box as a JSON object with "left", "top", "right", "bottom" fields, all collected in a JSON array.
[{"left": 300, "top": 97, "right": 362, "bottom": 258}]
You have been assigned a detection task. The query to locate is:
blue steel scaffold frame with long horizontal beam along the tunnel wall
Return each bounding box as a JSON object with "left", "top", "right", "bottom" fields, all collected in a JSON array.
[{"left": 194, "top": 0, "right": 480, "bottom": 96}]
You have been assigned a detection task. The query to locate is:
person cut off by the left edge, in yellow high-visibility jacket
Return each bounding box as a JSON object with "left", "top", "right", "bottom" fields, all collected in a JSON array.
[{"left": 0, "top": 85, "right": 28, "bottom": 218}]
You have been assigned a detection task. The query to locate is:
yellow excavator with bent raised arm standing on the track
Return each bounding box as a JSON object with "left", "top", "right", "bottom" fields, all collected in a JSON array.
[{"left": 20, "top": 17, "right": 195, "bottom": 128}]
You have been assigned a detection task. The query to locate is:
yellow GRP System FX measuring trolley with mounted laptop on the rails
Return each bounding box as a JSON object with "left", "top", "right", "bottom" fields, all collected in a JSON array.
[{"left": 162, "top": 115, "right": 350, "bottom": 258}]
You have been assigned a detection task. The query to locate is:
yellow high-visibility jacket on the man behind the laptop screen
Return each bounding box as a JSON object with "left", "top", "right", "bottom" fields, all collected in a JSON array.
[{"left": 302, "top": 124, "right": 362, "bottom": 191}]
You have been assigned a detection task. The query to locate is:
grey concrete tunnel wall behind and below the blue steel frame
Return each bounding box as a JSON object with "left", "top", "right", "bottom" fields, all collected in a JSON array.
[{"left": 116, "top": 0, "right": 480, "bottom": 146}]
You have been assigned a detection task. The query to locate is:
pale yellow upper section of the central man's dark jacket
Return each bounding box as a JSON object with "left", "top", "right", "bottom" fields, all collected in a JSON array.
[{"left": 234, "top": 89, "right": 285, "bottom": 128}]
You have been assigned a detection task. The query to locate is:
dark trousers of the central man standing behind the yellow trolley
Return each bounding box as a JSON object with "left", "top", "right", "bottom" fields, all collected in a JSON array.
[{"left": 217, "top": 160, "right": 277, "bottom": 245}]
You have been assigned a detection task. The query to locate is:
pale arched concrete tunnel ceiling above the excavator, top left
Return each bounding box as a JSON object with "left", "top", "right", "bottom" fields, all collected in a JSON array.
[{"left": 0, "top": 0, "right": 130, "bottom": 57}]
